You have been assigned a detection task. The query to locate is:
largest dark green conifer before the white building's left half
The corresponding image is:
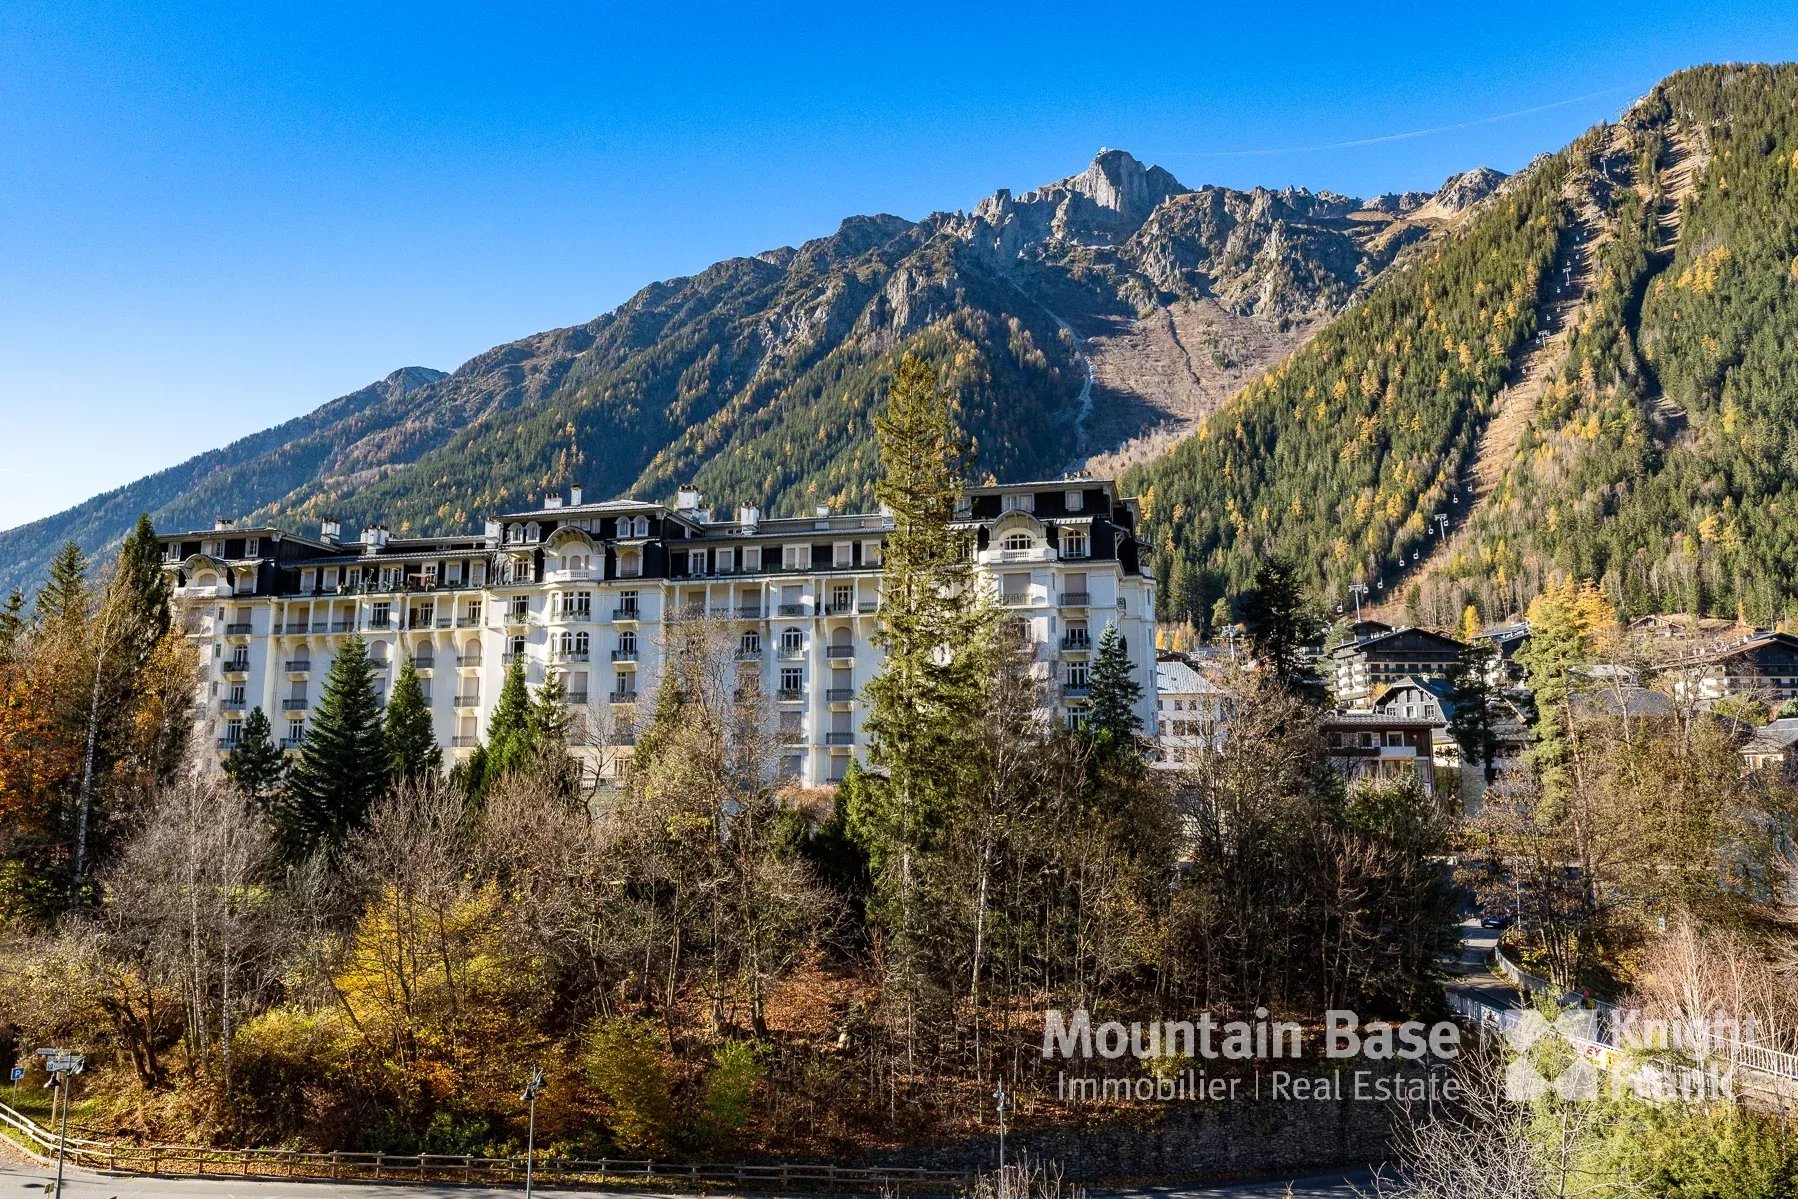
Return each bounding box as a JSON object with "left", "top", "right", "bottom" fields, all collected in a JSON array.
[{"left": 280, "top": 636, "right": 390, "bottom": 856}]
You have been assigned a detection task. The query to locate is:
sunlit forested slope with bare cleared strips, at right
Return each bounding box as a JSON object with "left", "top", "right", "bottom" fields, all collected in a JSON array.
[{"left": 1127, "top": 67, "right": 1798, "bottom": 624}]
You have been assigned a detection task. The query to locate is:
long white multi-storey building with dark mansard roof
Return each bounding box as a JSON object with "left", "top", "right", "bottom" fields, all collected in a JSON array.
[{"left": 162, "top": 478, "right": 1156, "bottom": 786}]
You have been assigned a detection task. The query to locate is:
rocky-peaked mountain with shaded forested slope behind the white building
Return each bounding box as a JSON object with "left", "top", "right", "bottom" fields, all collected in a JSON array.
[{"left": 0, "top": 151, "right": 1501, "bottom": 588}]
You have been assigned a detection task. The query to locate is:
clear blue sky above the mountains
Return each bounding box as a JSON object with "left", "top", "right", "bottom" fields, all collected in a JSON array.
[{"left": 0, "top": 0, "right": 1798, "bottom": 527}]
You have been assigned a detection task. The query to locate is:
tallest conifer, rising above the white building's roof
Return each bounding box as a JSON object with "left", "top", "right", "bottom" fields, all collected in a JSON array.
[{"left": 859, "top": 354, "right": 991, "bottom": 877}]
